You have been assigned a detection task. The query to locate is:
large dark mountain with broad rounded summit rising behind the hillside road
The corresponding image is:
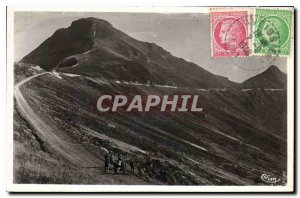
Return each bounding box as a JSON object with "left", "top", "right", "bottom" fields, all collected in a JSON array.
[{"left": 21, "top": 18, "right": 237, "bottom": 88}]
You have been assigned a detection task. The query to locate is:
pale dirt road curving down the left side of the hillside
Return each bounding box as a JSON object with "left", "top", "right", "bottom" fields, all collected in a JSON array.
[{"left": 14, "top": 72, "right": 150, "bottom": 184}]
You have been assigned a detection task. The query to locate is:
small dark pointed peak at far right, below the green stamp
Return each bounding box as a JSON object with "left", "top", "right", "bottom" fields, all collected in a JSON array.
[{"left": 242, "top": 65, "right": 287, "bottom": 89}]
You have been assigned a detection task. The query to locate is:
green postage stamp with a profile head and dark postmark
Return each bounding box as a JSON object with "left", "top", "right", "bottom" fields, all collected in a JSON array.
[{"left": 253, "top": 9, "right": 293, "bottom": 56}]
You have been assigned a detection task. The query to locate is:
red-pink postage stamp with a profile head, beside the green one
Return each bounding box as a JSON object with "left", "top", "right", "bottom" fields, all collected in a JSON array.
[{"left": 210, "top": 11, "right": 250, "bottom": 57}]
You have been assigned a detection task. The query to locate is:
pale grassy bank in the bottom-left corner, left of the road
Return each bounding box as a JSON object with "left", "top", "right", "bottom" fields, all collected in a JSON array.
[{"left": 14, "top": 108, "right": 109, "bottom": 184}]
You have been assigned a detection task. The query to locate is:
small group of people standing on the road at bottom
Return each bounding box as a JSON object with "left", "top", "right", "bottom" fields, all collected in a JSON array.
[{"left": 104, "top": 151, "right": 134, "bottom": 174}]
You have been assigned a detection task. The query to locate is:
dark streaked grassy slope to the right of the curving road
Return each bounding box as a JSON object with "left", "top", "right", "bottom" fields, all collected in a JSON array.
[{"left": 14, "top": 71, "right": 286, "bottom": 185}]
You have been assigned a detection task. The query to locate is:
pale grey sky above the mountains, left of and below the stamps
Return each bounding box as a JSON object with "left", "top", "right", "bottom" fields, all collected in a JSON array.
[{"left": 14, "top": 12, "right": 286, "bottom": 82}]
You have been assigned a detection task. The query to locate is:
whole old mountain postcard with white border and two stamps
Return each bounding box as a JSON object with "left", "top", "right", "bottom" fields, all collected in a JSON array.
[{"left": 7, "top": 7, "right": 294, "bottom": 192}]
